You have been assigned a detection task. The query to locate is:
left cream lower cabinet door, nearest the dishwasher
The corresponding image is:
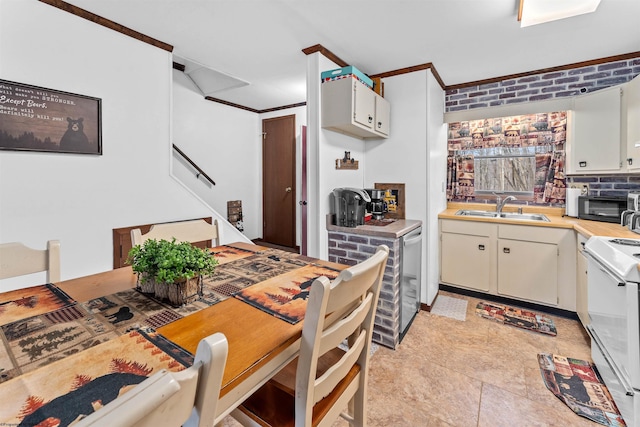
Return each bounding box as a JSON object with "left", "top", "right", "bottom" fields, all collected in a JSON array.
[{"left": 440, "top": 233, "right": 495, "bottom": 292}]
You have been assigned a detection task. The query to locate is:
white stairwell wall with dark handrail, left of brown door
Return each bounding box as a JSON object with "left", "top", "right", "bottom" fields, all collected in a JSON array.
[{"left": 172, "top": 70, "right": 262, "bottom": 240}]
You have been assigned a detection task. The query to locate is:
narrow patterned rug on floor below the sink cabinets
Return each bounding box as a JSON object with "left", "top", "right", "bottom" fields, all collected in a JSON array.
[{"left": 476, "top": 302, "right": 558, "bottom": 336}]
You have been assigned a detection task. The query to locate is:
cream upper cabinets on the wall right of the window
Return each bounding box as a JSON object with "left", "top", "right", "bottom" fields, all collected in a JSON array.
[{"left": 567, "top": 76, "right": 640, "bottom": 174}]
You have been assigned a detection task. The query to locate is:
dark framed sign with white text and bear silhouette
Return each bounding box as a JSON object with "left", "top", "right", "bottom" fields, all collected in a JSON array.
[{"left": 0, "top": 80, "right": 102, "bottom": 154}]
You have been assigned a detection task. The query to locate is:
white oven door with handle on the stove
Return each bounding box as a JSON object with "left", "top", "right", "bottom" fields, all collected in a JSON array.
[{"left": 587, "top": 252, "right": 640, "bottom": 392}]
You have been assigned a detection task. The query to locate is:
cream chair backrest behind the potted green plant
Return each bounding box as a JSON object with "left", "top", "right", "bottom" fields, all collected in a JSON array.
[{"left": 131, "top": 219, "right": 220, "bottom": 246}]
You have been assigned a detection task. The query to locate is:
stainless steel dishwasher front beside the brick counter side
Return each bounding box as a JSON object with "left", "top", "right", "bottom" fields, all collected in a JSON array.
[{"left": 400, "top": 227, "right": 422, "bottom": 341}]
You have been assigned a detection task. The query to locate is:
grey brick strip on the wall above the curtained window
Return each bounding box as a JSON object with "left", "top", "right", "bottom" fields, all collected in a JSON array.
[{"left": 445, "top": 57, "right": 640, "bottom": 112}]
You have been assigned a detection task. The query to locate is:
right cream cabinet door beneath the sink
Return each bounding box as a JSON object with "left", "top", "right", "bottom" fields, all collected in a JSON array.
[{"left": 498, "top": 239, "right": 558, "bottom": 305}]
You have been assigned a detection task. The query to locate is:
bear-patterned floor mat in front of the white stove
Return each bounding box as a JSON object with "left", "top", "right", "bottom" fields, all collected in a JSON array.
[{"left": 538, "top": 353, "right": 626, "bottom": 427}]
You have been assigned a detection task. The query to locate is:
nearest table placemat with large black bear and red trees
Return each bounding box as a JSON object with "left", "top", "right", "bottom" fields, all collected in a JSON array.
[{"left": 0, "top": 329, "right": 193, "bottom": 426}]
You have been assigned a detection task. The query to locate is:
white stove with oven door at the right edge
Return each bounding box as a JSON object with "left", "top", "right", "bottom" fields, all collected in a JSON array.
[{"left": 585, "top": 236, "right": 640, "bottom": 426}]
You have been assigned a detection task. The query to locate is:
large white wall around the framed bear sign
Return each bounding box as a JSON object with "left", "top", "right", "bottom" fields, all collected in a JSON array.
[{"left": 0, "top": 0, "right": 211, "bottom": 290}]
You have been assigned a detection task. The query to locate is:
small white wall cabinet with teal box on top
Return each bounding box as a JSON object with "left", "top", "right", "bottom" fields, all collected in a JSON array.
[{"left": 322, "top": 78, "right": 391, "bottom": 138}]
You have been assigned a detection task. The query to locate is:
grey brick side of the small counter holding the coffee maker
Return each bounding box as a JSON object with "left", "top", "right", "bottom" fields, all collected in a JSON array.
[{"left": 328, "top": 231, "right": 401, "bottom": 349}]
